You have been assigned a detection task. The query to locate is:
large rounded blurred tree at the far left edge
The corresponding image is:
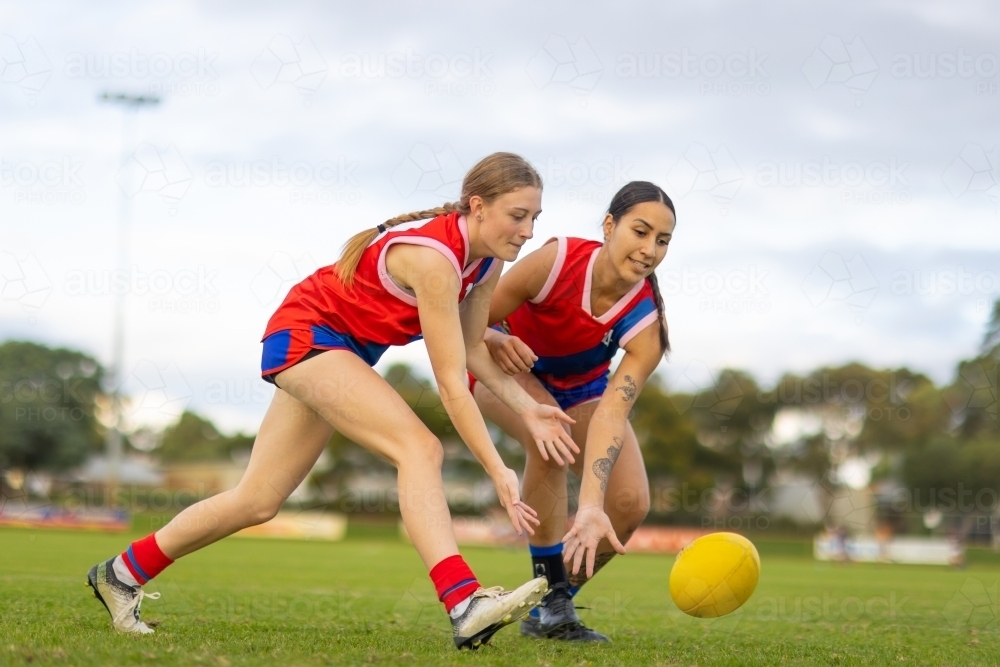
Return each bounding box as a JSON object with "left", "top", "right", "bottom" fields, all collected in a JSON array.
[{"left": 0, "top": 341, "right": 106, "bottom": 470}]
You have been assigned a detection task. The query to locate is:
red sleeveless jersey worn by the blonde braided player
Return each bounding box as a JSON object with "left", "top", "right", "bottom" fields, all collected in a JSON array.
[{"left": 261, "top": 211, "right": 500, "bottom": 346}]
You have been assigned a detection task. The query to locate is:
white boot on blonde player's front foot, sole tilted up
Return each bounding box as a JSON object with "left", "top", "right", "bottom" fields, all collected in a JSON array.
[{"left": 451, "top": 577, "right": 549, "bottom": 649}]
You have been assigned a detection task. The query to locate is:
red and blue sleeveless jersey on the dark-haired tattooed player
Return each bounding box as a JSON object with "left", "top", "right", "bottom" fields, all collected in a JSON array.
[{"left": 506, "top": 237, "right": 659, "bottom": 389}]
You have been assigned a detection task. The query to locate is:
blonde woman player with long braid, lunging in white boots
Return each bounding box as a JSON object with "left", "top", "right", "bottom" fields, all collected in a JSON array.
[{"left": 88, "top": 153, "right": 579, "bottom": 648}]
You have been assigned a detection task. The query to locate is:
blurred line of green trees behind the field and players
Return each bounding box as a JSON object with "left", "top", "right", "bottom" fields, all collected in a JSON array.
[{"left": 0, "top": 301, "right": 1000, "bottom": 528}]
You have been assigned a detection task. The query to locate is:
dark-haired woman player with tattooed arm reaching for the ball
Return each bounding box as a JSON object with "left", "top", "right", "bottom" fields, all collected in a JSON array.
[{"left": 473, "top": 181, "right": 676, "bottom": 641}]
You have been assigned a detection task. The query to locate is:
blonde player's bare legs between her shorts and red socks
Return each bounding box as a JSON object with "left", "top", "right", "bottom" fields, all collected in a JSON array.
[{"left": 156, "top": 350, "right": 458, "bottom": 569}]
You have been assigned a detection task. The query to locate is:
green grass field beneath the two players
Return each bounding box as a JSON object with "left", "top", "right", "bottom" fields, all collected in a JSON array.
[{"left": 0, "top": 529, "right": 1000, "bottom": 667}]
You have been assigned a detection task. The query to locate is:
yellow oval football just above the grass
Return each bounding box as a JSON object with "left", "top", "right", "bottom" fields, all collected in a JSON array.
[{"left": 670, "top": 533, "right": 760, "bottom": 618}]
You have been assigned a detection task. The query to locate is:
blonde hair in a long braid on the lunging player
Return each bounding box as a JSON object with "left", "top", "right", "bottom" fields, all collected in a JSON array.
[{"left": 337, "top": 153, "right": 542, "bottom": 286}]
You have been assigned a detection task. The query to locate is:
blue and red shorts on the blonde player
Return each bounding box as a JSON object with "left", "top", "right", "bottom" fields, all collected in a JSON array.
[{"left": 260, "top": 324, "right": 389, "bottom": 386}]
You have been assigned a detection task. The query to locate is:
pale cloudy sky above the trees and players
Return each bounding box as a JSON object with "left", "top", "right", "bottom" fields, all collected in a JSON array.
[{"left": 0, "top": 1, "right": 1000, "bottom": 430}]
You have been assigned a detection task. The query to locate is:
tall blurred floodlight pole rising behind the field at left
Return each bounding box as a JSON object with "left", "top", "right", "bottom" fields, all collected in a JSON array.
[{"left": 100, "top": 92, "right": 160, "bottom": 506}]
